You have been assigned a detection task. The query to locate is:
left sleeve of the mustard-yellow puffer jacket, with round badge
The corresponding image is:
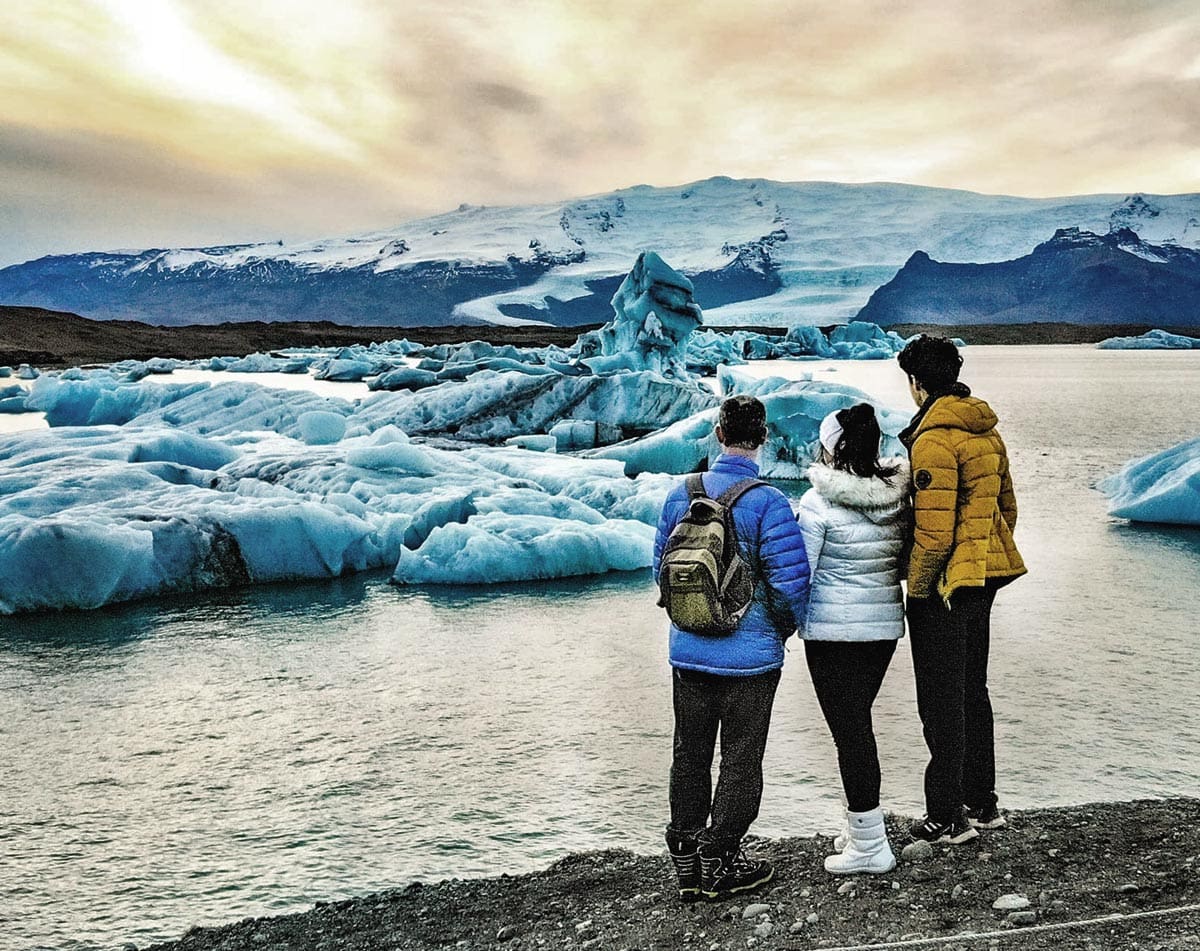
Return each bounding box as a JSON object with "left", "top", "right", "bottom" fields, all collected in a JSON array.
[{"left": 908, "top": 435, "right": 959, "bottom": 598}]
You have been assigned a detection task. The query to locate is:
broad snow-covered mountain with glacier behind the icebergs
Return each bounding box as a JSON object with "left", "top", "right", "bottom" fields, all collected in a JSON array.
[{"left": 0, "top": 178, "right": 1200, "bottom": 327}]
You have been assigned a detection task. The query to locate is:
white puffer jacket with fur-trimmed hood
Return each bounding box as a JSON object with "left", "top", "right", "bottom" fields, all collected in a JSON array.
[{"left": 797, "top": 459, "right": 911, "bottom": 641}]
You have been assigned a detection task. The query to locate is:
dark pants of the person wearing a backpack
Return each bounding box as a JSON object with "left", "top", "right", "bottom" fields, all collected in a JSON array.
[{"left": 670, "top": 668, "right": 780, "bottom": 849}]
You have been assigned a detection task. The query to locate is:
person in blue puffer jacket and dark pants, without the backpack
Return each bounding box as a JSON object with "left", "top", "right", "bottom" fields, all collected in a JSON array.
[{"left": 654, "top": 396, "right": 809, "bottom": 901}]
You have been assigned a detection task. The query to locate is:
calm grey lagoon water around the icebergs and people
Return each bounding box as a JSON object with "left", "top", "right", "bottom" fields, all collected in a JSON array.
[{"left": 0, "top": 347, "right": 1200, "bottom": 949}]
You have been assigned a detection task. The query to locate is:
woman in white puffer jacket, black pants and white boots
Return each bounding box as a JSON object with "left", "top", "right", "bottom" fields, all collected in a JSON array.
[{"left": 797, "top": 403, "right": 911, "bottom": 875}]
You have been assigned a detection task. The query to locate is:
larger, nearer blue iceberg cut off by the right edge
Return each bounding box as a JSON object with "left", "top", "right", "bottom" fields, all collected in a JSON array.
[{"left": 1099, "top": 438, "right": 1200, "bottom": 525}]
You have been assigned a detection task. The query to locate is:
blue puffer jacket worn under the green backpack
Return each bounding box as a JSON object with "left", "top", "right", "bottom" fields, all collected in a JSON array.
[{"left": 654, "top": 453, "right": 809, "bottom": 677}]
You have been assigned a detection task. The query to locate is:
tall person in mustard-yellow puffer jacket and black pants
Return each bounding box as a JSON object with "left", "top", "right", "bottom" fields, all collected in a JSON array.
[{"left": 899, "top": 334, "right": 1026, "bottom": 843}]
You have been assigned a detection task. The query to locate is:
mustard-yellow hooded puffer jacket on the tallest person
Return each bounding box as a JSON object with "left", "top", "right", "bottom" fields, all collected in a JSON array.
[{"left": 900, "top": 385, "right": 1026, "bottom": 602}]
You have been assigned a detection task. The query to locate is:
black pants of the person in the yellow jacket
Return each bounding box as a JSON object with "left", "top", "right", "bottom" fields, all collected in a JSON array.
[{"left": 907, "top": 584, "right": 997, "bottom": 823}]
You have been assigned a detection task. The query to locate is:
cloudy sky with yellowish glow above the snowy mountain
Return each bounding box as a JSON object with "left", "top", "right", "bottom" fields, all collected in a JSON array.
[{"left": 0, "top": 0, "right": 1200, "bottom": 267}]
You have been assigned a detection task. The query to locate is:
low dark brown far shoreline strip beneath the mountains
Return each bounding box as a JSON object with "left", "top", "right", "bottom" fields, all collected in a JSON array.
[{"left": 0, "top": 306, "right": 1198, "bottom": 367}]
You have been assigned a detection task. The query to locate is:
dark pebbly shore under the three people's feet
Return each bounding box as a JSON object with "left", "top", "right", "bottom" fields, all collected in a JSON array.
[{"left": 142, "top": 799, "right": 1200, "bottom": 951}]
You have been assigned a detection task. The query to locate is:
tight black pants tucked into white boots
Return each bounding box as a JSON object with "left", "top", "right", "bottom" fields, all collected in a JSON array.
[{"left": 804, "top": 640, "right": 896, "bottom": 812}]
